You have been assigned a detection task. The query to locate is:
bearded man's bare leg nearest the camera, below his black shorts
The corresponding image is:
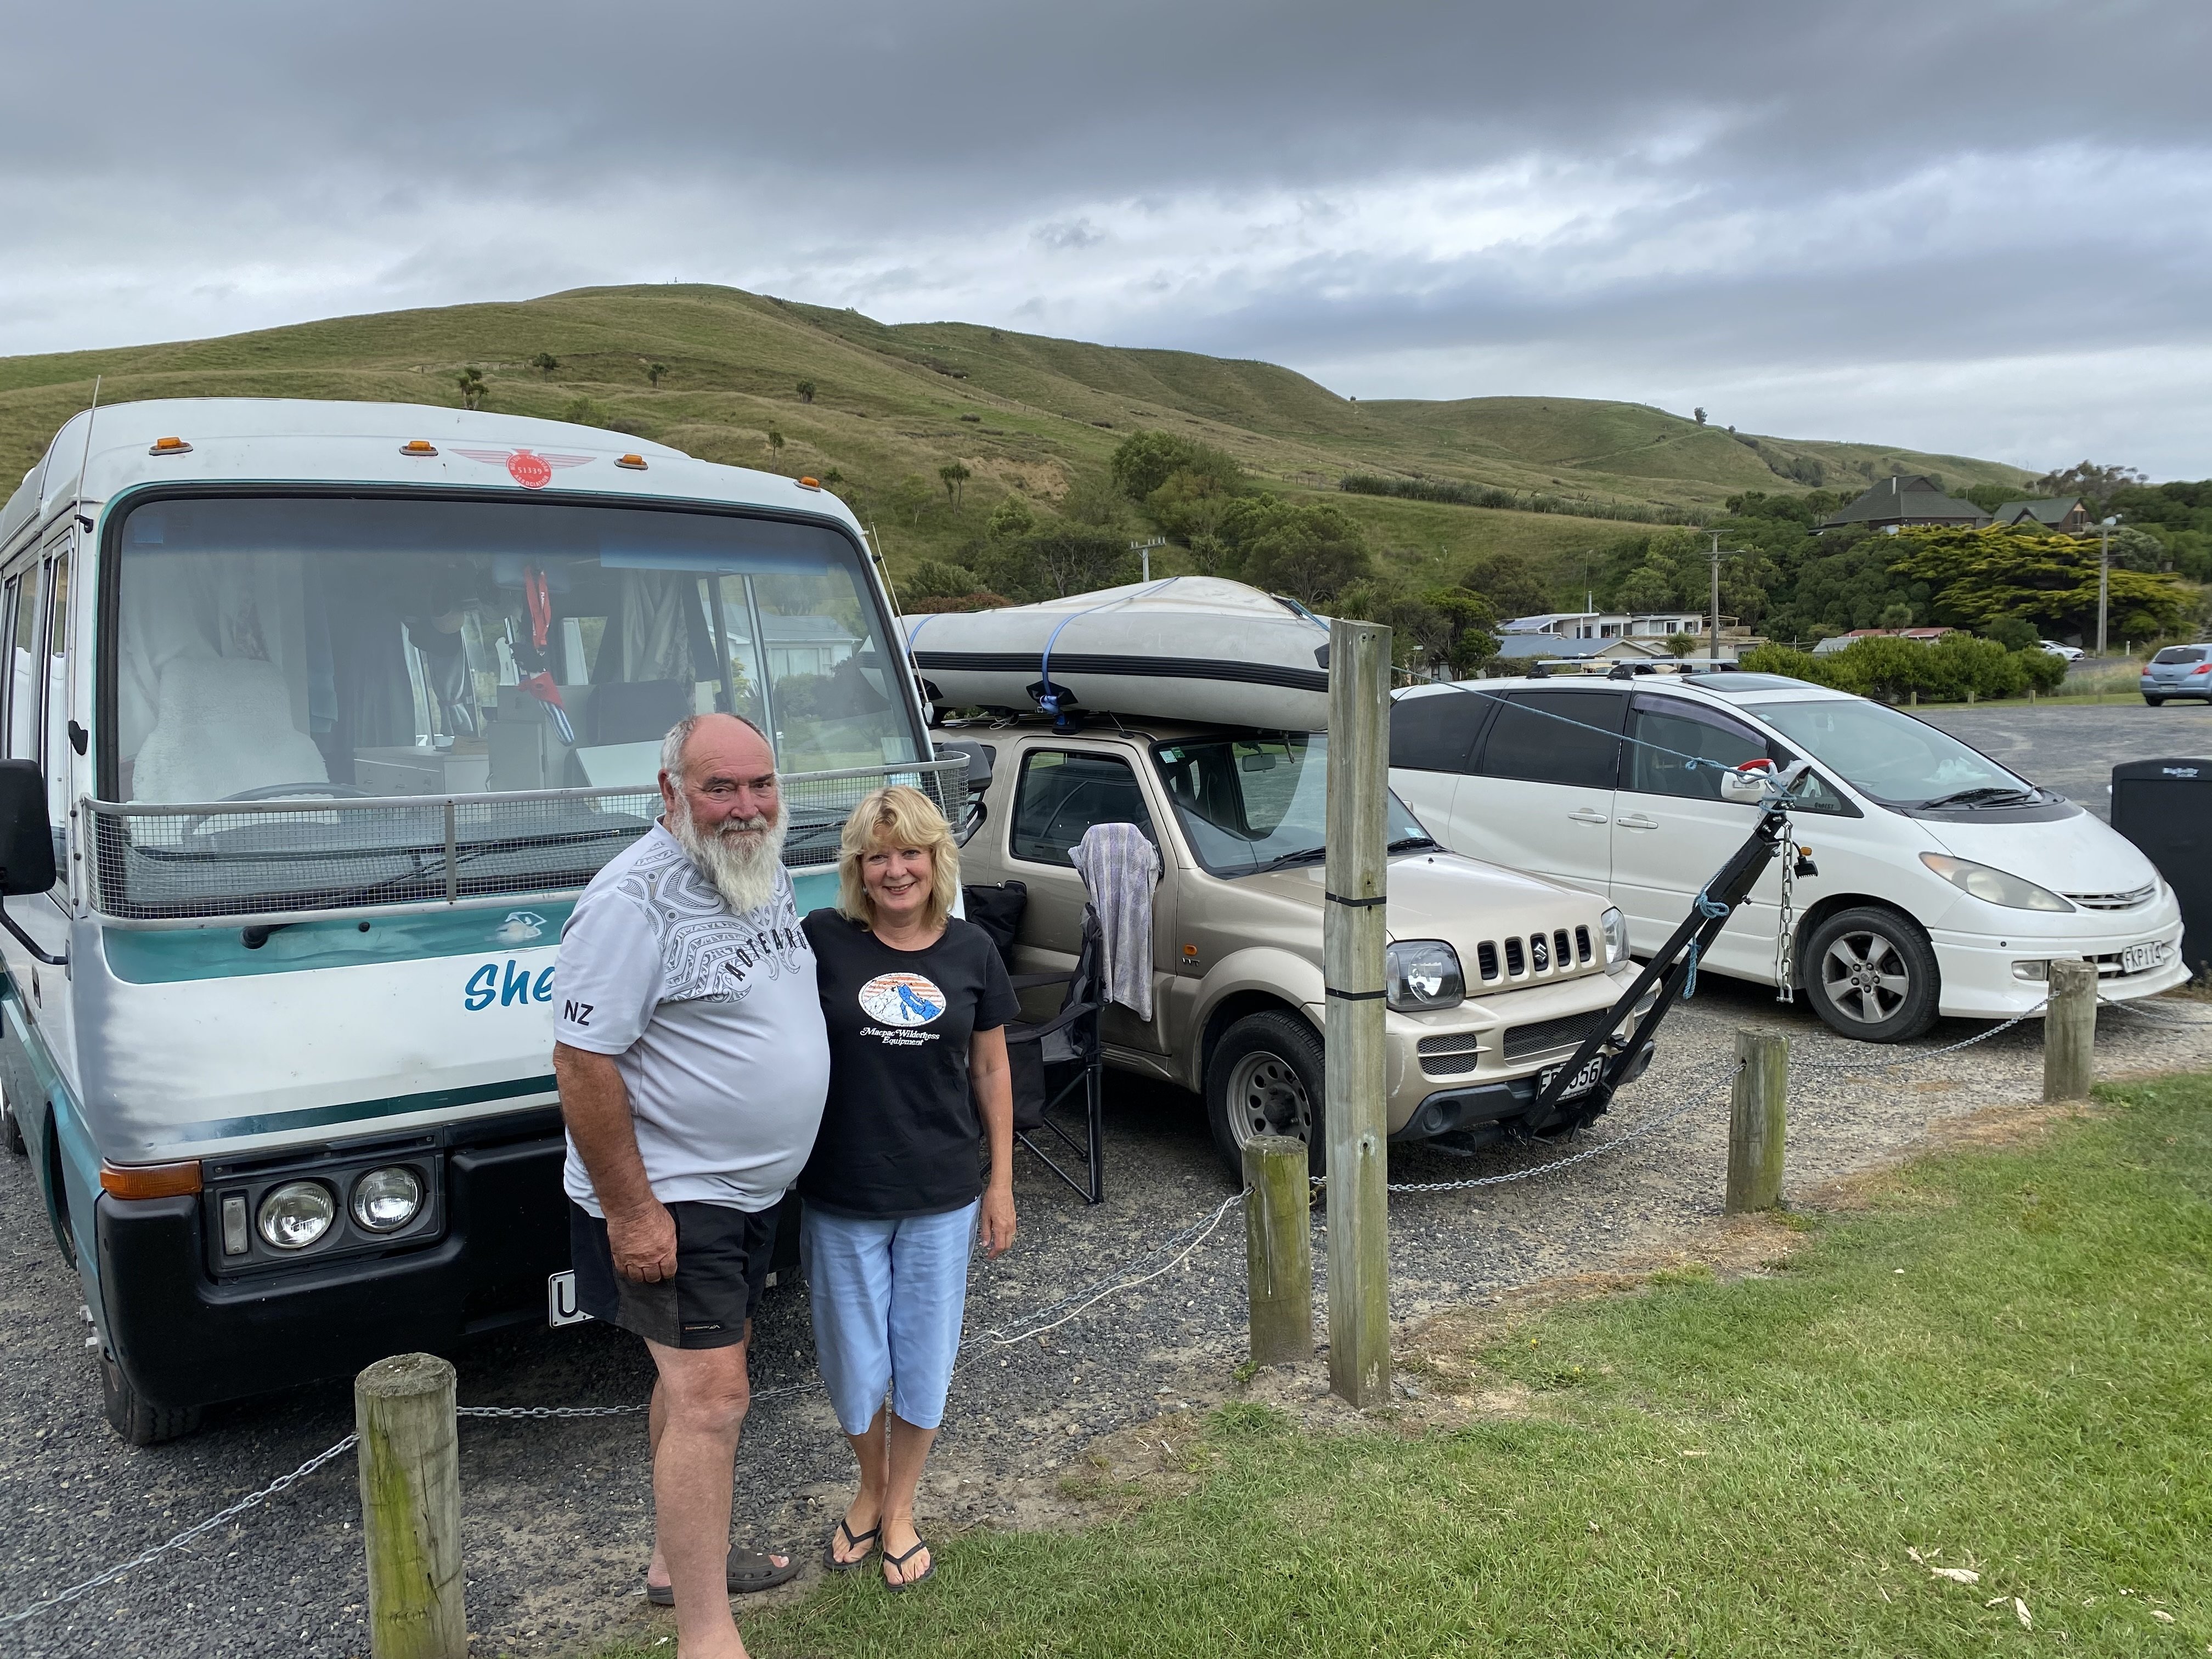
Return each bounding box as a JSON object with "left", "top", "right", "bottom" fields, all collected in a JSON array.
[{"left": 646, "top": 1340, "right": 750, "bottom": 1659}]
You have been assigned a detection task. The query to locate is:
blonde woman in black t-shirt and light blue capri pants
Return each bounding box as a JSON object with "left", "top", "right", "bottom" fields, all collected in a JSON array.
[{"left": 799, "top": 785, "right": 1020, "bottom": 1590}]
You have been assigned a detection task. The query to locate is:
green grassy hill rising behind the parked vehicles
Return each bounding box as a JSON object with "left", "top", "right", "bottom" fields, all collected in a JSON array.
[{"left": 0, "top": 283, "right": 2024, "bottom": 582}]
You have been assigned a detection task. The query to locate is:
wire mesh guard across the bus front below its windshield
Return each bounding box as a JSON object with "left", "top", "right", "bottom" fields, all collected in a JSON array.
[{"left": 80, "top": 754, "right": 967, "bottom": 927}]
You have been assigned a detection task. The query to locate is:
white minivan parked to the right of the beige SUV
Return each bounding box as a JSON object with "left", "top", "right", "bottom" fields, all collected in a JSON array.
[{"left": 1389, "top": 673, "right": 2188, "bottom": 1042}]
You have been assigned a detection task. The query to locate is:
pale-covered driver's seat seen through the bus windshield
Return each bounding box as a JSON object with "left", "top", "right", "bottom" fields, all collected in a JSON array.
[{"left": 131, "top": 654, "right": 330, "bottom": 803}]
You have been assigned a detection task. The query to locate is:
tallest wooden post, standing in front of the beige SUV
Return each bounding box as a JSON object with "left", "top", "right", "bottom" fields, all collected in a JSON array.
[{"left": 1321, "top": 619, "right": 1389, "bottom": 1407}]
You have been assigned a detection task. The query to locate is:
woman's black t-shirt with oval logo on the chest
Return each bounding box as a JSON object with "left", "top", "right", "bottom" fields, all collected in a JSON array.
[{"left": 799, "top": 909, "right": 1022, "bottom": 1221}]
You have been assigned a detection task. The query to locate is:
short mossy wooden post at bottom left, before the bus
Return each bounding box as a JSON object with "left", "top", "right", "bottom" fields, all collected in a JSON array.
[{"left": 354, "top": 1354, "right": 469, "bottom": 1659}]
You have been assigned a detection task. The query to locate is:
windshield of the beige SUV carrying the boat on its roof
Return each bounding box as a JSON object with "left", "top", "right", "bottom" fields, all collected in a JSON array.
[{"left": 1153, "top": 732, "right": 1434, "bottom": 876}]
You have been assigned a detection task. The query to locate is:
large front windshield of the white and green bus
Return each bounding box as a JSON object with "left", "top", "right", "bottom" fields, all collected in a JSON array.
[{"left": 101, "top": 498, "right": 927, "bottom": 803}]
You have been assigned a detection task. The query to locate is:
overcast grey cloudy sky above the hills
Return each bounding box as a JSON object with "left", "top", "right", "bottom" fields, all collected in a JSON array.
[{"left": 0, "top": 0, "right": 2212, "bottom": 478}]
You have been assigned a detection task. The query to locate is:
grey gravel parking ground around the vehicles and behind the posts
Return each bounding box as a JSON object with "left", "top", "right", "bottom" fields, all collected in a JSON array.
[{"left": 13, "top": 706, "right": 2212, "bottom": 1659}]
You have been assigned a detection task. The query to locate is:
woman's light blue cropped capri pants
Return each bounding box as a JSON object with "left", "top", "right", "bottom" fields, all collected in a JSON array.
[{"left": 799, "top": 1201, "right": 982, "bottom": 1434}]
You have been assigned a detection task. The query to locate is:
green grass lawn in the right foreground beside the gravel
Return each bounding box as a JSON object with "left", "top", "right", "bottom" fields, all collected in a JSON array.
[{"left": 608, "top": 1077, "right": 2212, "bottom": 1659}]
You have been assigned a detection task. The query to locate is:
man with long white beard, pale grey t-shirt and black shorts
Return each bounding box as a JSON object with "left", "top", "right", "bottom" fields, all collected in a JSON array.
[{"left": 553, "top": 714, "right": 830, "bottom": 1659}]
